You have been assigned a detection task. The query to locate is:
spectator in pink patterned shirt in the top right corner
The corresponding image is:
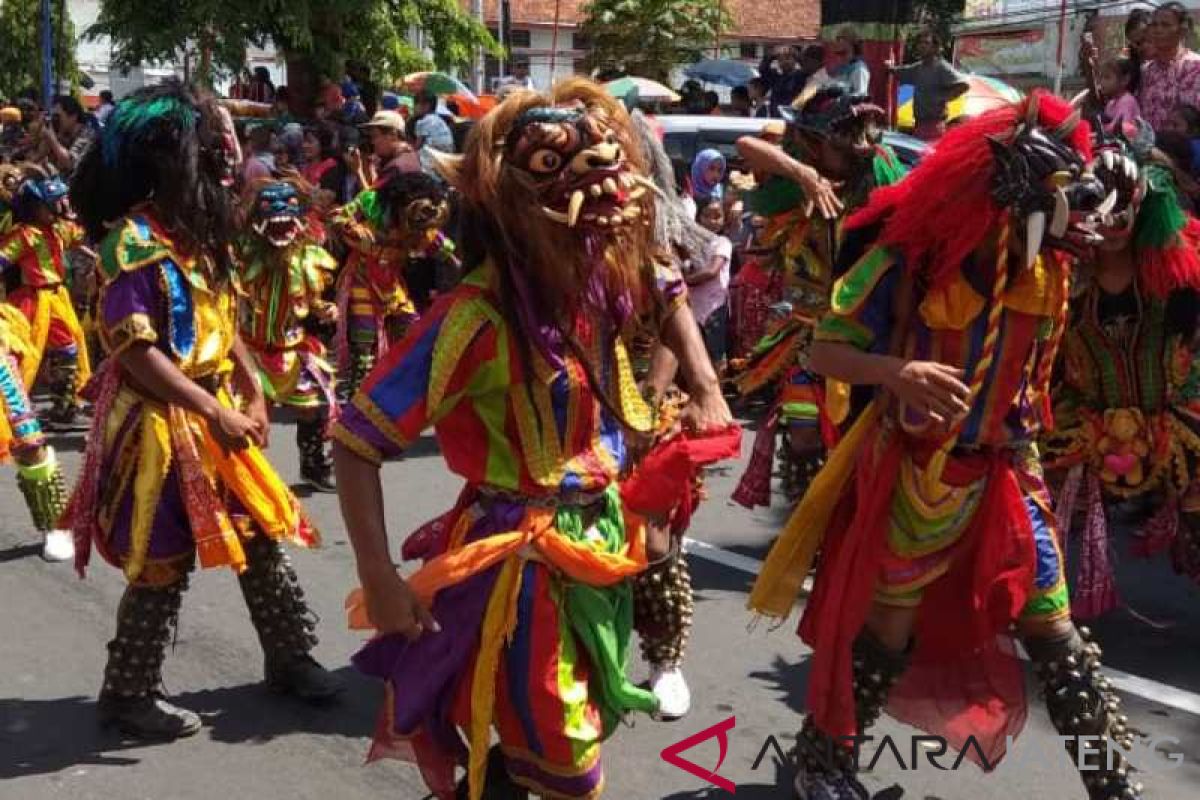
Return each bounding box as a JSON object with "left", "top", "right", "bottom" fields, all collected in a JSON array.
[{"left": 1138, "top": 2, "right": 1200, "bottom": 131}]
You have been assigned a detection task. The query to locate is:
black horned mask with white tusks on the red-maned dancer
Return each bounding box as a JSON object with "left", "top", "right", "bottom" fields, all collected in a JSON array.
[{"left": 988, "top": 94, "right": 1117, "bottom": 266}]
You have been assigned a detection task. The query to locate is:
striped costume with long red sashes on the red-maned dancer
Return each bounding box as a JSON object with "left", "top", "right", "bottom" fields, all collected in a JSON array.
[{"left": 750, "top": 234, "right": 1070, "bottom": 759}]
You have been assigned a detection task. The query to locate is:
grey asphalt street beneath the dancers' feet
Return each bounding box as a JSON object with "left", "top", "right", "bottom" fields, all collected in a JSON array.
[{"left": 0, "top": 412, "right": 1200, "bottom": 800}]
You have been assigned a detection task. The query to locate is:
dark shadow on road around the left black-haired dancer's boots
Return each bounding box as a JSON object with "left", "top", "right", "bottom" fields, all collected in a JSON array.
[{"left": 0, "top": 667, "right": 382, "bottom": 781}]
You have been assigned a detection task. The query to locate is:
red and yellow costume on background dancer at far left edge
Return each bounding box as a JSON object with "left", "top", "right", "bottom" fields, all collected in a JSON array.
[{"left": 0, "top": 219, "right": 91, "bottom": 402}]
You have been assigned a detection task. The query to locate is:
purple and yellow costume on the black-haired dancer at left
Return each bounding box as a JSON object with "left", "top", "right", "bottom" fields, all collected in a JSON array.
[{"left": 65, "top": 213, "right": 318, "bottom": 585}]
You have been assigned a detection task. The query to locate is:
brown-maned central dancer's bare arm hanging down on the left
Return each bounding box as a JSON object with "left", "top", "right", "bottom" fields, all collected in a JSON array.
[{"left": 334, "top": 441, "right": 440, "bottom": 639}]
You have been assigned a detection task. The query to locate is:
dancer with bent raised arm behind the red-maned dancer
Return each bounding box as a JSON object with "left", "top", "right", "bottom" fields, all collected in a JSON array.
[{"left": 733, "top": 85, "right": 904, "bottom": 507}]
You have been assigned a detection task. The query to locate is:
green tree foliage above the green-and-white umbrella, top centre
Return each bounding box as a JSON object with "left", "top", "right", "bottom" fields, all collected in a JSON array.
[{"left": 581, "top": 0, "right": 733, "bottom": 82}]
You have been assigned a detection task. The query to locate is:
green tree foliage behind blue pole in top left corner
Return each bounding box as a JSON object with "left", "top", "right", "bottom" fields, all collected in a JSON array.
[{"left": 0, "top": 0, "right": 79, "bottom": 97}]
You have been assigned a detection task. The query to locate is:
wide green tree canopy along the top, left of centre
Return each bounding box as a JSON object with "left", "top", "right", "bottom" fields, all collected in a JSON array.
[{"left": 88, "top": 0, "right": 496, "bottom": 86}]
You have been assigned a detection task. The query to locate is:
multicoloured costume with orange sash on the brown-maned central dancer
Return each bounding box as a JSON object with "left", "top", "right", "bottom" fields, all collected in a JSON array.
[{"left": 334, "top": 257, "right": 685, "bottom": 798}]
